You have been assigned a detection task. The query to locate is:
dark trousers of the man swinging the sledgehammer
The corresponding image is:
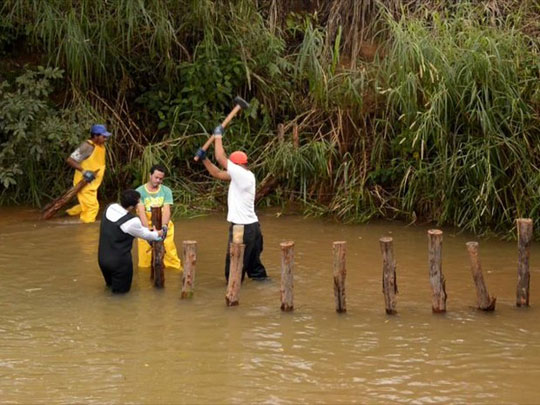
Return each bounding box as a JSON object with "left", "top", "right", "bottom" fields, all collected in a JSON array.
[{"left": 225, "top": 222, "right": 267, "bottom": 281}]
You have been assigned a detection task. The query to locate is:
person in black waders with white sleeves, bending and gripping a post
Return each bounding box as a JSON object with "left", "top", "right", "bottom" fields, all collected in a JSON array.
[{"left": 98, "top": 190, "right": 163, "bottom": 293}]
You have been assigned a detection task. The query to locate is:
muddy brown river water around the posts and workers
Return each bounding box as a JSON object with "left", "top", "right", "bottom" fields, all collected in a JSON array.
[{"left": 0, "top": 208, "right": 540, "bottom": 404}]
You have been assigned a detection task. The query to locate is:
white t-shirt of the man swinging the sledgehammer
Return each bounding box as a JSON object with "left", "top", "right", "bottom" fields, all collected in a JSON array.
[{"left": 227, "top": 160, "right": 259, "bottom": 225}]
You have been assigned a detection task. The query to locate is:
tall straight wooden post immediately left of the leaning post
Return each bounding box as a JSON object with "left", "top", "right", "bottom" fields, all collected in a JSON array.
[{"left": 428, "top": 229, "right": 446, "bottom": 313}]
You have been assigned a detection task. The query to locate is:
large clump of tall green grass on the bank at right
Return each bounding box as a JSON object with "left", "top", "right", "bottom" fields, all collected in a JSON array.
[{"left": 377, "top": 4, "right": 540, "bottom": 231}]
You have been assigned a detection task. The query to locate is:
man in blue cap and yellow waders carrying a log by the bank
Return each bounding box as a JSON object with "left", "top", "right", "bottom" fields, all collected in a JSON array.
[{"left": 66, "top": 124, "right": 111, "bottom": 223}]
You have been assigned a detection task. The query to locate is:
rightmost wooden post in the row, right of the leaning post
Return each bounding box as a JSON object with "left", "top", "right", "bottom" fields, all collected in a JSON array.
[{"left": 516, "top": 218, "right": 533, "bottom": 307}]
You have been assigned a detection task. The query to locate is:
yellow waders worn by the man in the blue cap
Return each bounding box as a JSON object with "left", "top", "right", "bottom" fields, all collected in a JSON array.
[{"left": 66, "top": 140, "right": 105, "bottom": 223}]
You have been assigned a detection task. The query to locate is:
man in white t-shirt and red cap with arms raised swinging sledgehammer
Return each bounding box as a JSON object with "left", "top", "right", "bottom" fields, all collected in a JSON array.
[{"left": 197, "top": 125, "right": 267, "bottom": 280}]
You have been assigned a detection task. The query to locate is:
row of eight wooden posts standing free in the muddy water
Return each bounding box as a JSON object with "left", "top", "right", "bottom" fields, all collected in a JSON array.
[{"left": 162, "top": 218, "right": 533, "bottom": 314}]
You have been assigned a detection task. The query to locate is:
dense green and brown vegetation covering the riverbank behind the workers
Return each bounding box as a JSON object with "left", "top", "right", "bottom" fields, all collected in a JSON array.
[{"left": 0, "top": 0, "right": 540, "bottom": 233}]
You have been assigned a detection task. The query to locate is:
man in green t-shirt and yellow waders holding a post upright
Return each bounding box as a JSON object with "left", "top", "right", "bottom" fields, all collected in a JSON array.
[{"left": 137, "top": 165, "right": 182, "bottom": 270}]
